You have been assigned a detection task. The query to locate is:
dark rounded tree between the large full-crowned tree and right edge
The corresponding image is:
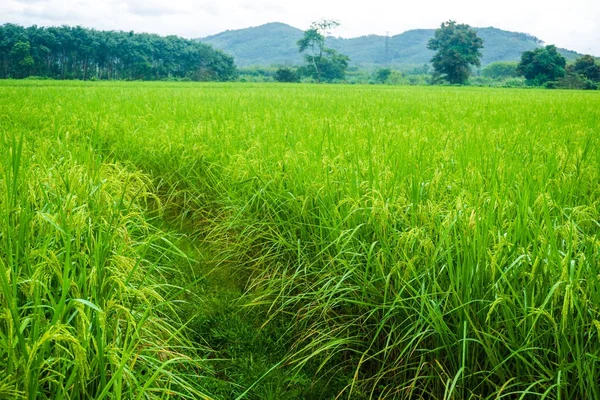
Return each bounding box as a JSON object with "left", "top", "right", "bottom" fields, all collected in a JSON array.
[{"left": 518, "top": 45, "right": 567, "bottom": 86}]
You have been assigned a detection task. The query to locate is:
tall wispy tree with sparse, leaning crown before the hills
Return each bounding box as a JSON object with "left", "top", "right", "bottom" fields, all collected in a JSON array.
[{"left": 297, "top": 20, "right": 350, "bottom": 83}]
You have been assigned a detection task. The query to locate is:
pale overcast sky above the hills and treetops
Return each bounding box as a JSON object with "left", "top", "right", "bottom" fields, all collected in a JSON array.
[{"left": 0, "top": 0, "right": 600, "bottom": 56}]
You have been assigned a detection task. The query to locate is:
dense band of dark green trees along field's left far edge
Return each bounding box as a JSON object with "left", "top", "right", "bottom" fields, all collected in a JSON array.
[{"left": 0, "top": 24, "right": 237, "bottom": 81}]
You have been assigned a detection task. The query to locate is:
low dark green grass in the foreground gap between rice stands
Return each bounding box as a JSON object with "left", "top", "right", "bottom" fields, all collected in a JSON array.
[{"left": 190, "top": 270, "right": 343, "bottom": 400}]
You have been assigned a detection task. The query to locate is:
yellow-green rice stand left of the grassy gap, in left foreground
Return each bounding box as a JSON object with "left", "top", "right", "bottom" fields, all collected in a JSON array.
[{"left": 0, "top": 97, "right": 216, "bottom": 399}]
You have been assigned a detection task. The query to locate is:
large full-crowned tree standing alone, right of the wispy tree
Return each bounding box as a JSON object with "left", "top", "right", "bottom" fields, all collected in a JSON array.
[{"left": 427, "top": 21, "right": 483, "bottom": 84}]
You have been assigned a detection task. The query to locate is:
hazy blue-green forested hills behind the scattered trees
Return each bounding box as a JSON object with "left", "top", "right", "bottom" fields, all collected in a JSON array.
[{"left": 199, "top": 22, "right": 579, "bottom": 66}]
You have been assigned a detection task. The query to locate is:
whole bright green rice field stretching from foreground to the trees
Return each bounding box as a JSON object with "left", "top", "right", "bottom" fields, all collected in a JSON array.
[{"left": 0, "top": 81, "right": 600, "bottom": 399}]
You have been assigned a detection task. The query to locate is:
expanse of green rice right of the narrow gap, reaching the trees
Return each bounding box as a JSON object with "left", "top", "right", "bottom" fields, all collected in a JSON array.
[{"left": 2, "top": 82, "right": 600, "bottom": 399}]
